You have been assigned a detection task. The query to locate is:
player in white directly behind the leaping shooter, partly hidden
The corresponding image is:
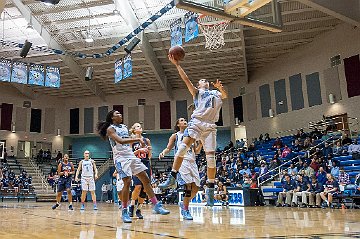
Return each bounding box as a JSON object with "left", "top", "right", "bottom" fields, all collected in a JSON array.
[{"left": 159, "top": 118, "right": 202, "bottom": 220}]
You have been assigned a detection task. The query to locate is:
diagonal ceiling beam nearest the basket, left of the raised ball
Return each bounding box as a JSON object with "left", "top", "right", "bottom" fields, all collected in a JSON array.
[{"left": 115, "top": 0, "right": 173, "bottom": 99}]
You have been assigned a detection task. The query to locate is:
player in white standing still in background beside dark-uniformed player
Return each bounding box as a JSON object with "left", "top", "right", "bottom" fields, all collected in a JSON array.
[{"left": 75, "top": 150, "right": 98, "bottom": 210}]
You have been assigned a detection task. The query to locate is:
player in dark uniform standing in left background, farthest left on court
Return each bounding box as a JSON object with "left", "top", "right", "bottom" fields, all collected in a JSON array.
[{"left": 52, "top": 154, "right": 75, "bottom": 211}]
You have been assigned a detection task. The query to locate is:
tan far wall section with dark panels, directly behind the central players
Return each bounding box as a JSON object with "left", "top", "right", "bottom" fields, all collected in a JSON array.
[{"left": 59, "top": 88, "right": 232, "bottom": 135}]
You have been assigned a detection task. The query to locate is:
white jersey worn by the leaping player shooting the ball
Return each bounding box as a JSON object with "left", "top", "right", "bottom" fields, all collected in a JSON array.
[{"left": 191, "top": 89, "right": 222, "bottom": 123}]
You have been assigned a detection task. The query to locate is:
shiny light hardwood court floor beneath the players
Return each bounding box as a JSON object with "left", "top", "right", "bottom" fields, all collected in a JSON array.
[{"left": 0, "top": 202, "right": 360, "bottom": 239}]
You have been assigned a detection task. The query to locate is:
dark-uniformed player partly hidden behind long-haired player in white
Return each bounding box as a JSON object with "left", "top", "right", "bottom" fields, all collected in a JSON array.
[{"left": 129, "top": 123, "right": 152, "bottom": 219}]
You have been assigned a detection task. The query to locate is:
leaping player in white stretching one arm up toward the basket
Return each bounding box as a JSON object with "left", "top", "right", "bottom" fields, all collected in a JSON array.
[{"left": 159, "top": 55, "right": 227, "bottom": 206}]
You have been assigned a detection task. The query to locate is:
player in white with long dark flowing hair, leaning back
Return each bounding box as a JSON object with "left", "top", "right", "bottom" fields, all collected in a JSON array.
[{"left": 97, "top": 110, "right": 170, "bottom": 223}]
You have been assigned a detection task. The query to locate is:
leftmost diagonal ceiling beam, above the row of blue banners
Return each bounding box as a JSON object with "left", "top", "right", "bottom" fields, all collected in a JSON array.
[{"left": 13, "top": 0, "right": 106, "bottom": 101}]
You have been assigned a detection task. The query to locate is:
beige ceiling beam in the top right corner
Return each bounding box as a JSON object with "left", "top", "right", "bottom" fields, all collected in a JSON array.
[{"left": 299, "top": 0, "right": 360, "bottom": 27}]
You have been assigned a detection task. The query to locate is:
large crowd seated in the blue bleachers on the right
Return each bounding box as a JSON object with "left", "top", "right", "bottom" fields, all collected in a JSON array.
[{"left": 152, "top": 129, "right": 360, "bottom": 207}]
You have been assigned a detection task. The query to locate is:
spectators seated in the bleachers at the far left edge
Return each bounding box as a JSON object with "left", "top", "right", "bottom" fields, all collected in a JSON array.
[{"left": 0, "top": 163, "right": 32, "bottom": 193}]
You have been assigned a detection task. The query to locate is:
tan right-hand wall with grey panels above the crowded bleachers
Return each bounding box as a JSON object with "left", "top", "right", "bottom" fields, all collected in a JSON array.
[{"left": 228, "top": 24, "right": 360, "bottom": 139}]
